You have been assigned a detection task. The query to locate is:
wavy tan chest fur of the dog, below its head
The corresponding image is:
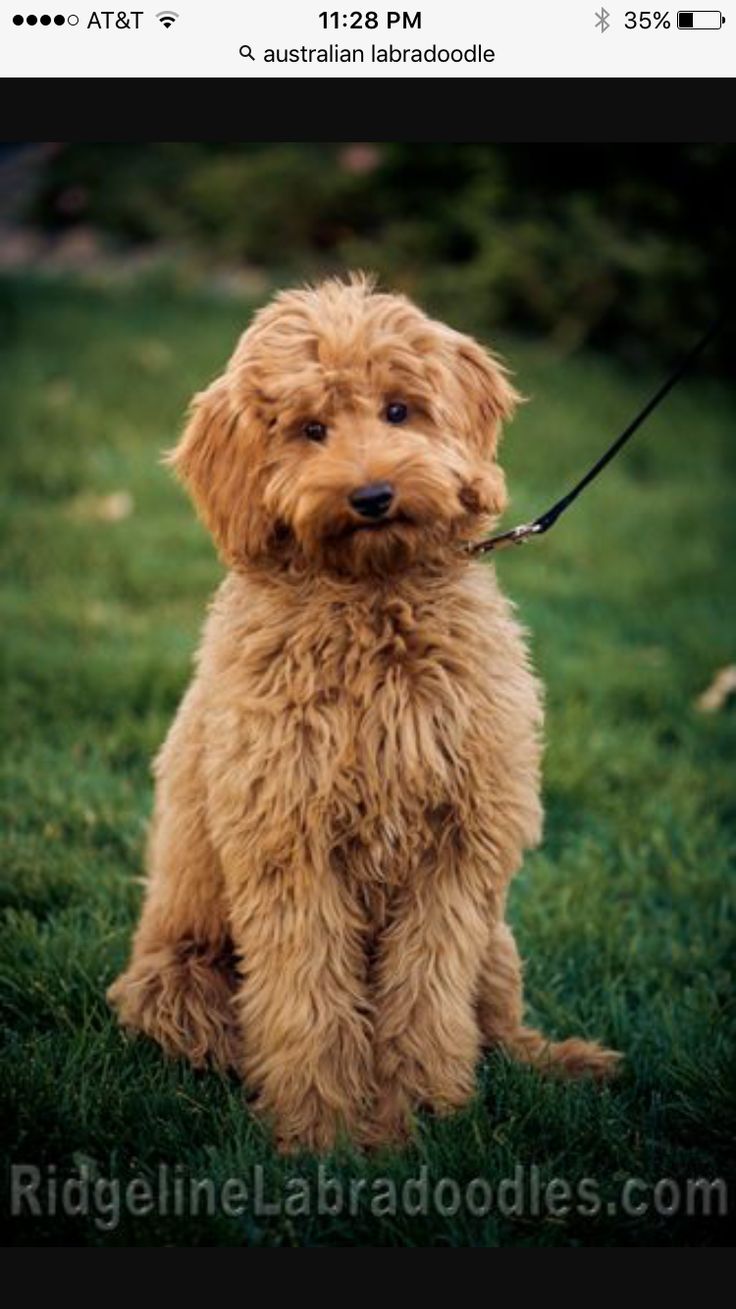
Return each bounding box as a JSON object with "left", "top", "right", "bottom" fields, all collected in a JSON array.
[{"left": 200, "top": 568, "right": 538, "bottom": 895}]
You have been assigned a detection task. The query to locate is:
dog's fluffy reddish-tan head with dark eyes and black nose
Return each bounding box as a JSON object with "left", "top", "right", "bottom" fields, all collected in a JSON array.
[{"left": 170, "top": 278, "right": 517, "bottom": 575}]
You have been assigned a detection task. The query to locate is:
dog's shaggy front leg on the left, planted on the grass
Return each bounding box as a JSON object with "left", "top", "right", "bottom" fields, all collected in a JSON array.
[{"left": 227, "top": 863, "right": 372, "bottom": 1151}]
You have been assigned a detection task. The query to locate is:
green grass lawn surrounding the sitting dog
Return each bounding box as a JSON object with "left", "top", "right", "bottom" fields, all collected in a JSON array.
[{"left": 0, "top": 283, "right": 736, "bottom": 1246}]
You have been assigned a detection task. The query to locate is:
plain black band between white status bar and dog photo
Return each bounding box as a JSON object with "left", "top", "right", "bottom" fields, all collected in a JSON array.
[{"left": 0, "top": 77, "right": 736, "bottom": 144}]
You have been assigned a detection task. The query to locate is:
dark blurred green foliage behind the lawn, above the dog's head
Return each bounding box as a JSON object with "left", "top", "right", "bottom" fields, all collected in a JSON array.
[{"left": 33, "top": 143, "right": 736, "bottom": 370}]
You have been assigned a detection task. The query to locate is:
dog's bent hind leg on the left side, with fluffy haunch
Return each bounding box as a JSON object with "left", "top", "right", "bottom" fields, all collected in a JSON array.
[{"left": 107, "top": 692, "right": 240, "bottom": 1068}]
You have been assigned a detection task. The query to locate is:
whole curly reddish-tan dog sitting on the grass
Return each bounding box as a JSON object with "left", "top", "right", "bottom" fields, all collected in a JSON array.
[{"left": 109, "top": 278, "right": 617, "bottom": 1149}]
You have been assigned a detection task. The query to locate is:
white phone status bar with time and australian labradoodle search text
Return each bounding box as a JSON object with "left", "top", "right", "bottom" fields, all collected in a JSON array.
[{"left": 0, "top": 0, "right": 736, "bottom": 77}]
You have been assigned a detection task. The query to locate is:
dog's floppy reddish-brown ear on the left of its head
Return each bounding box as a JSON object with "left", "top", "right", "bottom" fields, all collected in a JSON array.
[{"left": 165, "top": 376, "right": 266, "bottom": 564}]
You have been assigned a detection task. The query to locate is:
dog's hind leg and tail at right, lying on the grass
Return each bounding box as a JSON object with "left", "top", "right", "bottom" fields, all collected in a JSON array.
[{"left": 478, "top": 923, "right": 621, "bottom": 1081}]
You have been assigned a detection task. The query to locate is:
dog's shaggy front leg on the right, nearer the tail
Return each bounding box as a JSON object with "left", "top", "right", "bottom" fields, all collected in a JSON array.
[{"left": 371, "top": 867, "right": 487, "bottom": 1143}]
